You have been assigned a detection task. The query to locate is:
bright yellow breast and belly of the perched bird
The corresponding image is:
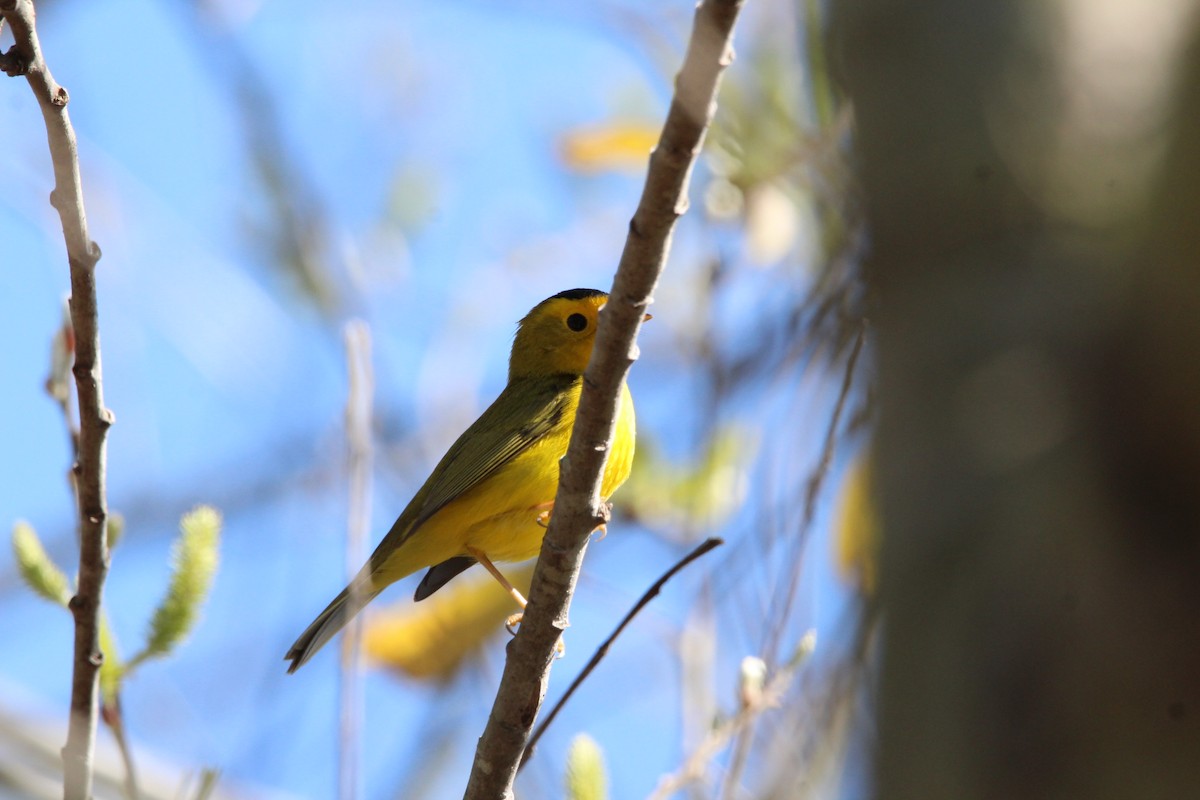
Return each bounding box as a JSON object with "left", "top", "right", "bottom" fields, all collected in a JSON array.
[{"left": 373, "top": 383, "right": 636, "bottom": 585}]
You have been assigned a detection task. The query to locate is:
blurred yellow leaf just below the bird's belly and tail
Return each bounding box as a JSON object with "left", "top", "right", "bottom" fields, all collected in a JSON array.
[{"left": 362, "top": 561, "right": 534, "bottom": 680}]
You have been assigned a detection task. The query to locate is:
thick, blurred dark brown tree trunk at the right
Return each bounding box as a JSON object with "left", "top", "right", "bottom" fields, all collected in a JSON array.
[{"left": 834, "top": 0, "right": 1200, "bottom": 800}]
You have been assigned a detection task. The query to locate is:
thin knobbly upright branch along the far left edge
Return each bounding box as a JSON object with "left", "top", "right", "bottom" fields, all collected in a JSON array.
[{"left": 0, "top": 0, "right": 113, "bottom": 800}]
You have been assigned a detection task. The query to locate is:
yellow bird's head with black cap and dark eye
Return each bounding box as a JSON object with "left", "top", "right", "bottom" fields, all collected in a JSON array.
[{"left": 509, "top": 289, "right": 608, "bottom": 380}]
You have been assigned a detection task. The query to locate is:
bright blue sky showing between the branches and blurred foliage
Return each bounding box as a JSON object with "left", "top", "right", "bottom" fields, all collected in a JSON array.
[{"left": 0, "top": 0, "right": 864, "bottom": 798}]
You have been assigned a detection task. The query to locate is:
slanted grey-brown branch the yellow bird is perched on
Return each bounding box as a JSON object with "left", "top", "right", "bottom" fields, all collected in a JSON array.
[{"left": 464, "top": 0, "right": 742, "bottom": 800}]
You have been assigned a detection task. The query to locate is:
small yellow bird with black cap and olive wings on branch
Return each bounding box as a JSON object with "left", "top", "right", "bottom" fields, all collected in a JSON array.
[{"left": 284, "top": 289, "right": 649, "bottom": 673}]
